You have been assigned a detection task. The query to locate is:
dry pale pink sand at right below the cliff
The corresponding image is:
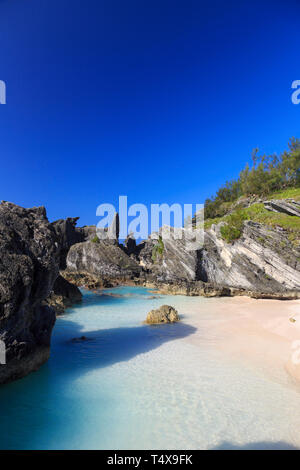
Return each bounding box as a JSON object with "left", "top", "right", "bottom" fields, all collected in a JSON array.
[{"left": 176, "top": 297, "right": 300, "bottom": 385}]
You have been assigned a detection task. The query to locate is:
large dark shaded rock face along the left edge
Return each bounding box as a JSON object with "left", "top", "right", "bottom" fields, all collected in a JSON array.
[{"left": 0, "top": 202, "right": 60, "bottom": 383}]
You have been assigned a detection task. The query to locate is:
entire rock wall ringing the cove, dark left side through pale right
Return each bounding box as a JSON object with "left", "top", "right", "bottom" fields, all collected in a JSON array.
[{"left": 0, "top": 196, "right": 300, "bottom": 383}]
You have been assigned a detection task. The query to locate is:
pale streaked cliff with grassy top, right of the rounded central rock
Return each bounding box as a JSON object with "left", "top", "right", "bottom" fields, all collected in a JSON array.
[{"left": 126, "top": 200, "right": 300, "bottom": 298}]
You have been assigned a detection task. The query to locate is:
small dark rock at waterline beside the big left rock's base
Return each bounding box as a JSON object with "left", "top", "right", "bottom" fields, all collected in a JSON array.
[{"left": 47, "top": 275, "right": 82, "bottom": 314}]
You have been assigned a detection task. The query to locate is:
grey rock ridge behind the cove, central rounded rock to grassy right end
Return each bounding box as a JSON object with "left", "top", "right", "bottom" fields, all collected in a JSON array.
[{"left": 60, "top": 199, "right": 300, "bottom": 298}]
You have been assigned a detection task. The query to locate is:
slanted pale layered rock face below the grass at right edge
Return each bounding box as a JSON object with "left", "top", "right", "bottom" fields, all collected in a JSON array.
[{"left": 199, "top": 221, "right": 300, "bottom": 293}]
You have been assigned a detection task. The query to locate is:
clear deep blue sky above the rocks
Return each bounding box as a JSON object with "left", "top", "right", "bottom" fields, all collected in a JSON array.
[{"left": 0, "top": 0, "right": 300, "bottom": 224}]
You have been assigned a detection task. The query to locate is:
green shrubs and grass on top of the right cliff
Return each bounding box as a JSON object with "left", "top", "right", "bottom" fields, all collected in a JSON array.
[{"left": 204, "top": 138, "right": 300, "bottom": 246}]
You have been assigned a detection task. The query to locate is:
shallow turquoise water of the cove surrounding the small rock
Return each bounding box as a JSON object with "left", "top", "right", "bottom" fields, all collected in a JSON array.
[{"left": 0, "top": 287, "right": 300, "bottom": 449}]
